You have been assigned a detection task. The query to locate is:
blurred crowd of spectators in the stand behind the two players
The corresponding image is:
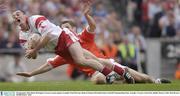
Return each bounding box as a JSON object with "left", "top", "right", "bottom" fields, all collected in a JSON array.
[{"left": 0, "top": 0, "right": 180, "bottom": 81}]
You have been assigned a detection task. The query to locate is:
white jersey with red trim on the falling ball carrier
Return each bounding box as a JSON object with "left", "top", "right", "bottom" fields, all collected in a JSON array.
[{"left": 19, "top": 15, "right": 62, "bottom": 50}]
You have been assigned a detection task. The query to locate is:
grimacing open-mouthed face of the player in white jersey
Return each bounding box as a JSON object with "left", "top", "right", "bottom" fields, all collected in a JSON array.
[{"left": 12, "top": 10, "right": 27, "bottom": 30}]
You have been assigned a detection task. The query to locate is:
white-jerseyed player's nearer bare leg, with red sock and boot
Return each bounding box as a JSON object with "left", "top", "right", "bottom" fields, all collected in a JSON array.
[{"left": 68, "top": 42, "right": 116, "bottom": 83}]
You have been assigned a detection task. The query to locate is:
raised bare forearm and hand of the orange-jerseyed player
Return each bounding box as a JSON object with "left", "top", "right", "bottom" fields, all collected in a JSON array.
[{"left": 83, "top": 2, "right": 96, "bottom": 33}]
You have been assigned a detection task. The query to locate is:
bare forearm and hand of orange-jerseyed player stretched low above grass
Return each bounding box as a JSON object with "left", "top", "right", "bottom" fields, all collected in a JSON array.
[{"left": 16, "top": 63, "right": 53, "bottom": 77}]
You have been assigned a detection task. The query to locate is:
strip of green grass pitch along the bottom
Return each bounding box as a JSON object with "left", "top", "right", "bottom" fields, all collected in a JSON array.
[{"left": 0, "top": 80, "right": 180, "bottom": 91}]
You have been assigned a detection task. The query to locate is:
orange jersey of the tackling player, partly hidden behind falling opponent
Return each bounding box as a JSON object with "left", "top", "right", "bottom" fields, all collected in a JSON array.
[{"left": 47, "top": 29, "right": 105, "bottom": 76}]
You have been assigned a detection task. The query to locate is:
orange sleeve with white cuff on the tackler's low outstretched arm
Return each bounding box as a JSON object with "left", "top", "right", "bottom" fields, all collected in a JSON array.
[{"left": 47, "top": 55, "right": 67, "bottom": 68}]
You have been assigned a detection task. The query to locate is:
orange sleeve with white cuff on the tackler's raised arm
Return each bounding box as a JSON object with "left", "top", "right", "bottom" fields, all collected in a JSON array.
[{"left": 80, "top": 27, "right": 95, "bottom": 42}]
